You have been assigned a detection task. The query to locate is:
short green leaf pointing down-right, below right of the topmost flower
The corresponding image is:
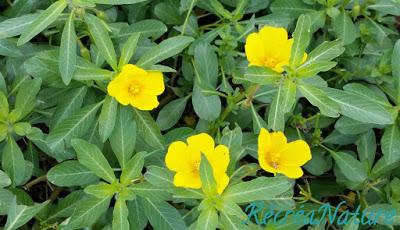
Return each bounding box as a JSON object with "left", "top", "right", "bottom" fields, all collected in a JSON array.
[{"left": 297, "top": 84, "right": 340, "bottom": 117}]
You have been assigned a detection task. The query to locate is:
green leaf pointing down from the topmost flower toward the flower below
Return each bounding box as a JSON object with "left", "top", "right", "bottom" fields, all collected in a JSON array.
[{"left": 268, "top": 80, "right": 296, "bottom": 131}]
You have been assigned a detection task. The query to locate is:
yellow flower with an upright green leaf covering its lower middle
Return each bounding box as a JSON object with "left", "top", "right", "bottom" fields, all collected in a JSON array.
[{"left": 165, "top": 133, "right": 229, "bottom": 194}]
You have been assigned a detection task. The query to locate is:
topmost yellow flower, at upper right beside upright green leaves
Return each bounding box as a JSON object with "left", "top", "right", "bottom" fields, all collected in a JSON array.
[{"left": 245, "top": 26, "right": 307, "bottom": 73}]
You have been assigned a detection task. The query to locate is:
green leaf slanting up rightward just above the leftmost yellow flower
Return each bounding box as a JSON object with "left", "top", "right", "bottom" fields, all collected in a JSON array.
[{"left": 136, "top": 36, "right": 193, "bottom": 68}]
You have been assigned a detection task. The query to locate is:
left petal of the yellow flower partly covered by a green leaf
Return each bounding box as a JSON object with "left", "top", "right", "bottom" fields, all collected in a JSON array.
[{"left": 165, "top": 141, "right": 201, "bottom": 172}]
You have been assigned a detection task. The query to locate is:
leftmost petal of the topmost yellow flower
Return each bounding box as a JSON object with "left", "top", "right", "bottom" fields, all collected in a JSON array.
[{"left": 244, "top": 33, "right": 264, "bottom": 66}]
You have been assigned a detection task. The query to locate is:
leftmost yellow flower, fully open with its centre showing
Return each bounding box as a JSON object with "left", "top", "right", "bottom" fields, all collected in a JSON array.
[{"left": 107, "top": 64, "right": 165, "bottom": 110}]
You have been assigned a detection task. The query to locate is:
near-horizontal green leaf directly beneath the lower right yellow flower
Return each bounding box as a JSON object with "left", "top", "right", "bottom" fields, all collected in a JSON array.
[{"left": 222, "top": 176, "right": 293, "bottom": 203}]
